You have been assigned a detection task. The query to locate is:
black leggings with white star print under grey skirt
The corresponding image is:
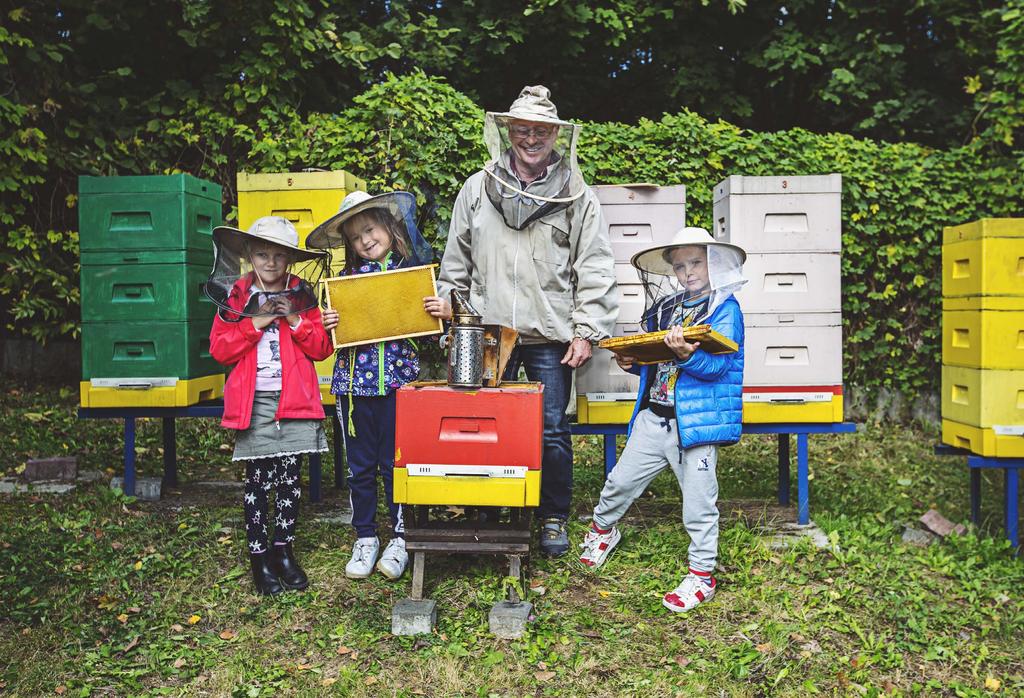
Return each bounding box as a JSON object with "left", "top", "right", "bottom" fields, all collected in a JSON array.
[{"left": 243, "top": 455, "right": 302, "bottom": 554}]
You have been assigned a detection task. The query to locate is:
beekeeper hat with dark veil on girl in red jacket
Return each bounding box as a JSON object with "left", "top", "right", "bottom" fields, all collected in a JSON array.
[{"left": 203, "top": 216, "right": 330, "bottom": 322}]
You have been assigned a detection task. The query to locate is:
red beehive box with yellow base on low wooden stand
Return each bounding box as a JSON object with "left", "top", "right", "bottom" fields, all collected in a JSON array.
[{"left": 394, "top": 383, "right": 544, "bottom": 507}]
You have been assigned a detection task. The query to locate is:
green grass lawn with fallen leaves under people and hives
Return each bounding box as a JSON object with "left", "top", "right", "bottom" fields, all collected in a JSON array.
[{"left": 0, "top": 385, "right": 1024, "bottom": 696}]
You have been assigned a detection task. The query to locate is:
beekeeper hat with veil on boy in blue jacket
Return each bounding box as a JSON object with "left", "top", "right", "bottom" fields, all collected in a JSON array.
[{"left": 630, "top": 227, "right": 746, "bottom": 329}]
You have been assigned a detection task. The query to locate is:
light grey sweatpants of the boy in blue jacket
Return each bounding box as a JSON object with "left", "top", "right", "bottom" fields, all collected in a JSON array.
[{"left": 594, "top": 409, "right": 718, "bottom": 572}]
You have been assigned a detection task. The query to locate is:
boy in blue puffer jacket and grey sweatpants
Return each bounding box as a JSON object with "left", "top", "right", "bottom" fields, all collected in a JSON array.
[{"left": 580, "top": 228, "right": 746, "bottom": 613}]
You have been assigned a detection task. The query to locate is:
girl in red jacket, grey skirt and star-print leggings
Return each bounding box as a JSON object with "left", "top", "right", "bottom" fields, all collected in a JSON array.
[{"left": 206, "top": 216, "right": 333, "bottom": 595}]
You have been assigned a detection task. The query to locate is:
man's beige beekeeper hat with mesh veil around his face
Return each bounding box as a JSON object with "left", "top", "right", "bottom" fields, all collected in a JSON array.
[{"left": 483, "top": 85, "right": 587, "bottom": 230}]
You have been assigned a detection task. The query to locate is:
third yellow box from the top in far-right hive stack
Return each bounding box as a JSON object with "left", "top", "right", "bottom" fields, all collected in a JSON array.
[{"left": 942, "top": 365, "right": 1024, "bottom": 427}]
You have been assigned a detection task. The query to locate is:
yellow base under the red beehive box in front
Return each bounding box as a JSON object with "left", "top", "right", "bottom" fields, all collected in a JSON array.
[{"left": 394, "top": 468, "right": 541, "bottom": 507}]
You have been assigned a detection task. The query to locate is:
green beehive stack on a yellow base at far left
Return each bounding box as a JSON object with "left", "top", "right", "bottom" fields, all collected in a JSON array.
[{"left": 79, "top": 174, "right": 224, "bottom": 407}]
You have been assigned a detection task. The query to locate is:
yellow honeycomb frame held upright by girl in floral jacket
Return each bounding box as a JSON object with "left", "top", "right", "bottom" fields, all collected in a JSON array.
[{"left": 324, "top": 265, "right": 441, "bottom": 349}]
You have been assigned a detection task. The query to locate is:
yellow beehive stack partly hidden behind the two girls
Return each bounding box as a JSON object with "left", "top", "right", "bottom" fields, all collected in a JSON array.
[{"left": 238, "top": 170, "right": 367, "bottom": 404}]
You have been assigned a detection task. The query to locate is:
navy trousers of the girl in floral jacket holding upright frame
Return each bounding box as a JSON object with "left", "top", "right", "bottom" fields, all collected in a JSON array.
[{"left": 338, "top": 391, "right": 406, "bottom": 538}]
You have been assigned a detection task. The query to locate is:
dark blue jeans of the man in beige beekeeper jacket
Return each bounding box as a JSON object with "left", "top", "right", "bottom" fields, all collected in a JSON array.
[{"left": 503, "top": 343, "right": 572, "bottom": 519}]
